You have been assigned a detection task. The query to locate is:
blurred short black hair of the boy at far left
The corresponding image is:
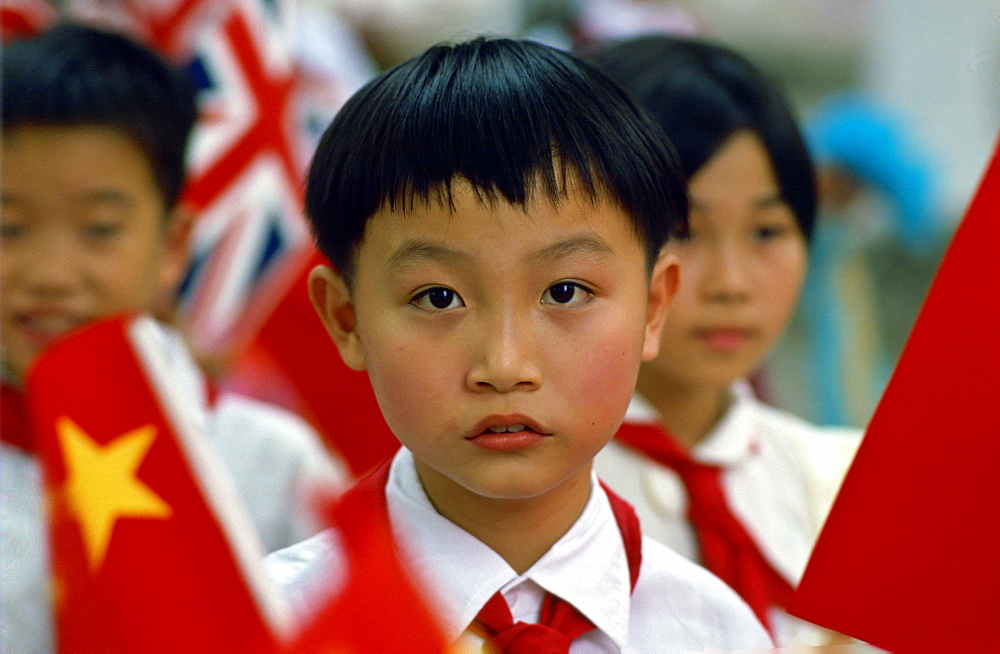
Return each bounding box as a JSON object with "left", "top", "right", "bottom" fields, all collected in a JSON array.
[{"left": 0, "top": 23, "right": 197, "bottom": 209}]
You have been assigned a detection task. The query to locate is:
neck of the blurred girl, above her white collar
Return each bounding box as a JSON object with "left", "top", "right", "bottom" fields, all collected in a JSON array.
[{"left": 636, "top": 374, "right": 730, "bottom": 449}]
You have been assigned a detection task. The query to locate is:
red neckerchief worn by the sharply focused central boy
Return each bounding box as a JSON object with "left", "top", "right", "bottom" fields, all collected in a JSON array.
[{"left": 340, "top": 460, "right": 642, "bottom": 654}]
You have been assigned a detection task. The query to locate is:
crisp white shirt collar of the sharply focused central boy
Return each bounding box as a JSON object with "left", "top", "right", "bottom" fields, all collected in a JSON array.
[{"left": 386, "top": 448, "right": 630, "bottom": 647}]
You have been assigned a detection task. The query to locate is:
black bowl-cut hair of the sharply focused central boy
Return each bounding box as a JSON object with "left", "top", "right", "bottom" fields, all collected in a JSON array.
[{"left": 305, "top": 37, "right": 687, "bottom": 284}]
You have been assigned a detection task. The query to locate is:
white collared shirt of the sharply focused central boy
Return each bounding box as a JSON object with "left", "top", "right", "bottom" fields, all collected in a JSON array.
[{"left": 268, "top": 449, "right": 772, "bottom": 654}]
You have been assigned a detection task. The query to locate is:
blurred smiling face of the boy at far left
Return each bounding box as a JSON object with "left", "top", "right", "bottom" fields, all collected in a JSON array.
[{"left": 0, "top": 127, "right": 184, "bottom": 381}]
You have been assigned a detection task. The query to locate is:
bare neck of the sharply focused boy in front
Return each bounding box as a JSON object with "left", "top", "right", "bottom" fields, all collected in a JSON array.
[{"left": 416, "top": 461, "right": 590, "bottom": 574}]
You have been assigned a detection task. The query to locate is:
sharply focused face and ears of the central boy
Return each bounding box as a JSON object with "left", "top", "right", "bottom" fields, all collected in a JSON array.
[{"left": 310, "top": 182, "right": 677, "bottom": 510}]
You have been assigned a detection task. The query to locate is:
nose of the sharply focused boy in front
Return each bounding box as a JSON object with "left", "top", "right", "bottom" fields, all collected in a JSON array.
[{"left": 466, "top": 317, "right": 542, "bottom": 393}]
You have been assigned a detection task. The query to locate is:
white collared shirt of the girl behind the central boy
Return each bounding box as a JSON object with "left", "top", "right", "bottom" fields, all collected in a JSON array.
[{"left": 594, "top": 382, "right": 861, "bottom": 644}]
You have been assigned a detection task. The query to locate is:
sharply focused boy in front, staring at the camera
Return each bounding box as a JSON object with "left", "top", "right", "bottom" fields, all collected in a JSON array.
[{"left": 270, "top": 39, "right": 771, "bottom": 652}]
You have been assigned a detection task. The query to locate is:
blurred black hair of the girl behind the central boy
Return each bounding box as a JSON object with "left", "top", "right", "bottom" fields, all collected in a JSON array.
[{"left": 587, "top": 34, "right": 816, "bottom": 239}]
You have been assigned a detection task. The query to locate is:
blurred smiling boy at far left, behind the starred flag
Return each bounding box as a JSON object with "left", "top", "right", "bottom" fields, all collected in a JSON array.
[{"left": 0, "top": 25, "right": 341, "bottom": 652}]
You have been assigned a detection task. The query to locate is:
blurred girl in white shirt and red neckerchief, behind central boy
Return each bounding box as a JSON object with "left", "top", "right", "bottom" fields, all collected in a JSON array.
[{"left": 591, "top": 35, "right": 860, "bottom": 645}]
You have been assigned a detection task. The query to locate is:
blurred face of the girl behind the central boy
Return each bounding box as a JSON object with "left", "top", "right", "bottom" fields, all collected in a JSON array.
[{"left": 640, "top": 131, "right": 806, "bottom": 389}]
